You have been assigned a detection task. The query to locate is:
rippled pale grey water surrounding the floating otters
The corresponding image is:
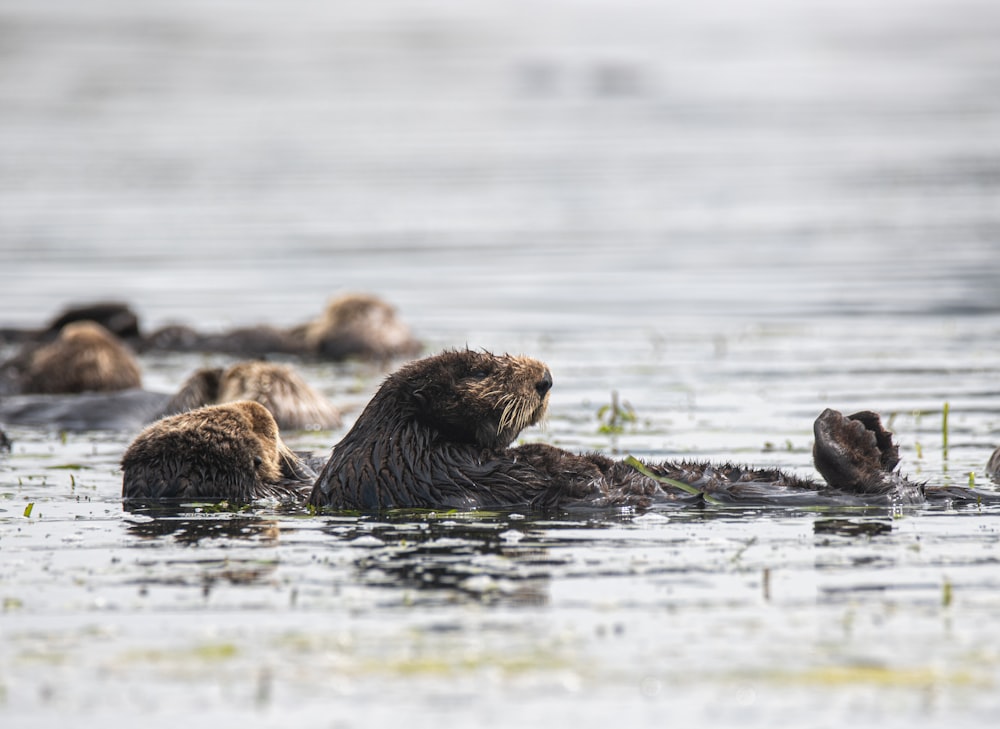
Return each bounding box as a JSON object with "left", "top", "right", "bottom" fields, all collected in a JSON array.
[{"left": 0, "top": 0, "right": 1000, "bottom": 727}]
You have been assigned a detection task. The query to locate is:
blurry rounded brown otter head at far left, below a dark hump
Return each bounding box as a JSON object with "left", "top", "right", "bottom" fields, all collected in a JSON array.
[{"left": 10, "top": 321, "right": 141, "bottom": 394}]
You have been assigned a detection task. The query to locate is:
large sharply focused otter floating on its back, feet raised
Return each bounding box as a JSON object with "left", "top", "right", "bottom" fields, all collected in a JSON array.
[{"left": 309, "top": 350, "right": 1000, "bottom": 511}]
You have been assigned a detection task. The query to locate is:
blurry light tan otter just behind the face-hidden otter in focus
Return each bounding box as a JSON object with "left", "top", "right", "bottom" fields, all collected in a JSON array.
[{"left": 164, "top": 360, "right": 341, "bottom": 430}]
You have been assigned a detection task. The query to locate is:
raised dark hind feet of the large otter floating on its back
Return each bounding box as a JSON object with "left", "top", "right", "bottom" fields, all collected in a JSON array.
[{"left": 813, "top": 408, "right": 899, "bottom": 488}]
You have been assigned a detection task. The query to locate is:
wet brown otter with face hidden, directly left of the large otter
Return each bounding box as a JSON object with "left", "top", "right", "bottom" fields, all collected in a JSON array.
[{"left": 121, "top": 401, "right": 315, "bottom": 502}]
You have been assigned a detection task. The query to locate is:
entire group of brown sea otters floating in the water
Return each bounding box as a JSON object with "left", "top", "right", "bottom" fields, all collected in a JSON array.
[{"left": 0, "top": 294, "right": 1000, "bottom": 512}]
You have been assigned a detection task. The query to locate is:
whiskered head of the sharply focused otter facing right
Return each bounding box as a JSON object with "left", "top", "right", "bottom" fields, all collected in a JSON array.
[{"left": 390, "top": 350, "right": 552, "bottom": 449}]
